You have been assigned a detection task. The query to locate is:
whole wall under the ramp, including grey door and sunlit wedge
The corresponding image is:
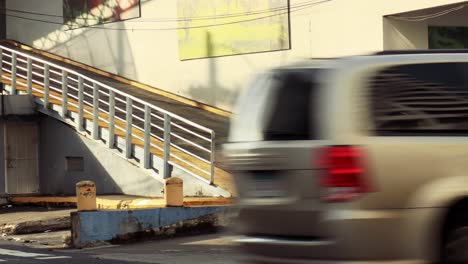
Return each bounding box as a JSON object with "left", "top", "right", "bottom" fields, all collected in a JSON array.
[{"left": 0, "top": 94, "right": 234, "bottom": 197}]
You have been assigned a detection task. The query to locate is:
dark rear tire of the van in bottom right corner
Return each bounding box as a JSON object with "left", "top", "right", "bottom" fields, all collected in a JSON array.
[{"left": 442, "top": 225, "right": 468, "bottom": 264}]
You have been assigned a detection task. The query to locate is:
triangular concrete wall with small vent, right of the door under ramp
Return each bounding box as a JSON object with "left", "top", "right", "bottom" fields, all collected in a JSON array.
[{"left": 39, "top": 116, "right": 162, "bottom": 197}]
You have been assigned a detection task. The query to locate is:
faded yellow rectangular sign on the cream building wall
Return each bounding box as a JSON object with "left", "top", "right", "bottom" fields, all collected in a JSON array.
[{"left": 178, "top": 0, "right": 290, "bottom": 60}]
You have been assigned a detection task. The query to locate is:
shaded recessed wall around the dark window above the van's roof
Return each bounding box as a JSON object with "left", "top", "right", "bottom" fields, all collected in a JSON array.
[{"left": 383, "top": 5, "right": 468, "bottom": 50}]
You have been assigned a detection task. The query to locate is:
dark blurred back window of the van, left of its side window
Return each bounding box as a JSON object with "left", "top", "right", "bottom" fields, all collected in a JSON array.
[{"left": 263, "top": 69, "right": 323, "bottom": 140}]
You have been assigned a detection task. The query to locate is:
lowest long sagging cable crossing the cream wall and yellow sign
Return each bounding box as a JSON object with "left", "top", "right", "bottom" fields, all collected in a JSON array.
[{"left": 4, "top": 0, "right": 332, "bottom": 31}]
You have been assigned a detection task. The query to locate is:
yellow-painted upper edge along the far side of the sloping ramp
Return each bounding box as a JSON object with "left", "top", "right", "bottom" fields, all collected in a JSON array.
[{"left": 4, "top": 40, "right": 232, "bottom": 117}]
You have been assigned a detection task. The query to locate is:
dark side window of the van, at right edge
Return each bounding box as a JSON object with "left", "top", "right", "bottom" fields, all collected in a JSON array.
[{"left": 370, "top": 63, "right": 468, "bottom": 135}]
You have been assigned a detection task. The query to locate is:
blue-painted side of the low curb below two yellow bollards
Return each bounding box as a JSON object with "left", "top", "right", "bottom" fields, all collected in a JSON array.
[{"left": 72, "top": 206, "right": 226, "bottom": 247}]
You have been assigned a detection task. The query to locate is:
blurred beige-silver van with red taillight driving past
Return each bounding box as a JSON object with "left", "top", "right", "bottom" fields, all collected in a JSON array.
[{"left": 224, "top": 51, "right": 468, "bottom": 263}]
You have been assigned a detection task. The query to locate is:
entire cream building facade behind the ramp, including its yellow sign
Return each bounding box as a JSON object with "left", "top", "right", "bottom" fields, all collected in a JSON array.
[{"left": 5, "top": 0, "right": 468, "bottom": 111}]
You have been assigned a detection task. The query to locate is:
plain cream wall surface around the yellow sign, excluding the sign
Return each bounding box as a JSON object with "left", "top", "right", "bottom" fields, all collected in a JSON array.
[{"left": 7, "top": 0, "right": 468, "bottom": 110}]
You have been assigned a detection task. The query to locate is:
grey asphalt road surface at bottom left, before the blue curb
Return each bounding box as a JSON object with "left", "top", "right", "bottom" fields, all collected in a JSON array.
[{"left": 0, "top": 234, "right": 244, "bottom": 264}]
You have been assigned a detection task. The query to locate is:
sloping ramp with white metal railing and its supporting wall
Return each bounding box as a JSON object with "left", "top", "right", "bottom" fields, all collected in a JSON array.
[{"left": 0, "top": 41, "right": 235, "bottom": 197}]
